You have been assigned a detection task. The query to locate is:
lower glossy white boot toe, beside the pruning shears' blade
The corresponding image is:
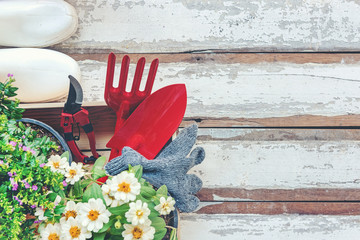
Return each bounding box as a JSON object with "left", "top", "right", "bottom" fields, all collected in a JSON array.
[{"left": 0, "top": 48, "right": 81, "bottom": 102}]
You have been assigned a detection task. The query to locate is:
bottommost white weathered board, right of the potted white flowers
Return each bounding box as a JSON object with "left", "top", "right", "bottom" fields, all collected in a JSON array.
[{"left": 179, "top": 213, "right": 360, "bottom": 240}]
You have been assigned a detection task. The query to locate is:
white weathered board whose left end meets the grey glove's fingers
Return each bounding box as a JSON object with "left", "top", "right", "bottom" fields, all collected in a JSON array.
[{"left": 190, "top": 141, "right": 360, "bottom": 189}]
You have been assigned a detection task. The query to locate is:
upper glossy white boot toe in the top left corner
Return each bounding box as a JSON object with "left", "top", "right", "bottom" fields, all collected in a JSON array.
[{"left": 0, "top": 0, "right": 78, "bottom": 47}]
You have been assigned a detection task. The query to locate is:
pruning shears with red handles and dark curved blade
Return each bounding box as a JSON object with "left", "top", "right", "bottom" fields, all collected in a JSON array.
[{"left": 60, "top": 75, "right": 99, "bottom": 163}]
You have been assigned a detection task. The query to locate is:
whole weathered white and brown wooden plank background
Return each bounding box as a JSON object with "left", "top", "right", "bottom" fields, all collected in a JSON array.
[{"left": 20, "top": 0, "right": 360, "bottom": 240}]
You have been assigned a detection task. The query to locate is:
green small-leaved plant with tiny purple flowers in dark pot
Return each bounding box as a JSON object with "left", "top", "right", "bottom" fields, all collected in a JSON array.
[{"left": 0, "top": 114, "right": 64, "bottom": 239}]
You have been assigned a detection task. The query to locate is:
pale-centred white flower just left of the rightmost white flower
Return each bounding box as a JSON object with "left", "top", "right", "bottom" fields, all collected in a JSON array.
[{"left": 125, "top": 200, "right": 150, "bottom": 225}]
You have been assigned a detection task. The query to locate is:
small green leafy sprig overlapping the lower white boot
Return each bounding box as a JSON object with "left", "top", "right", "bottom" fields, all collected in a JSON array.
[{"left": 0, "top": 74, "right": 25, "bottom": 119}]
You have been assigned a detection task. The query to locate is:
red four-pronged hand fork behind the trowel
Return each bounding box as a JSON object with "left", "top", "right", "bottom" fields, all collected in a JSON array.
[{"left": 104, "top": 53, "right": 159, "bottom": 159}]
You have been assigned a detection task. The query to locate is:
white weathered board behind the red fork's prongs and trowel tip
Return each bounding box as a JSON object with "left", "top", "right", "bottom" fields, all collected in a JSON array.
[{"left": 79, "top": 59, "right": 360, "bottom": 118}]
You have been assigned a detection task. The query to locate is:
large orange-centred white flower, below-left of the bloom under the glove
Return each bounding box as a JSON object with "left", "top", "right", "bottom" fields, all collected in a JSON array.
[{"left": 80, "top": 198, "right": 111, "bottom": 232}]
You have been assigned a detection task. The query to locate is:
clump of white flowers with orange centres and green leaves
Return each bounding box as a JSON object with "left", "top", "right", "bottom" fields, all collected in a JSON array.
[{"left": 32, "top": 155, "right": 176, "bottom": 240}]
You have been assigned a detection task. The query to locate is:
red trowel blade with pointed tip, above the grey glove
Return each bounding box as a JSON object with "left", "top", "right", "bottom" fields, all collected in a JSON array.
[{"left": 106, "top": 84, "right": 186, "bottom": 159}]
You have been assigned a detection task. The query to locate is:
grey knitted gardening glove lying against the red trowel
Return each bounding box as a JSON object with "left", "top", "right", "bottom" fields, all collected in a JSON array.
[{"left": 105, "top": 125, "right": 205, "bottom": 212}]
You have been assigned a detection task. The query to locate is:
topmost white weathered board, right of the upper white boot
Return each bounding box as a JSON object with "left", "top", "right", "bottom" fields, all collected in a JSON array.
[{"left": 58, "top": 0, "right": 360, "bottom": 53}]
